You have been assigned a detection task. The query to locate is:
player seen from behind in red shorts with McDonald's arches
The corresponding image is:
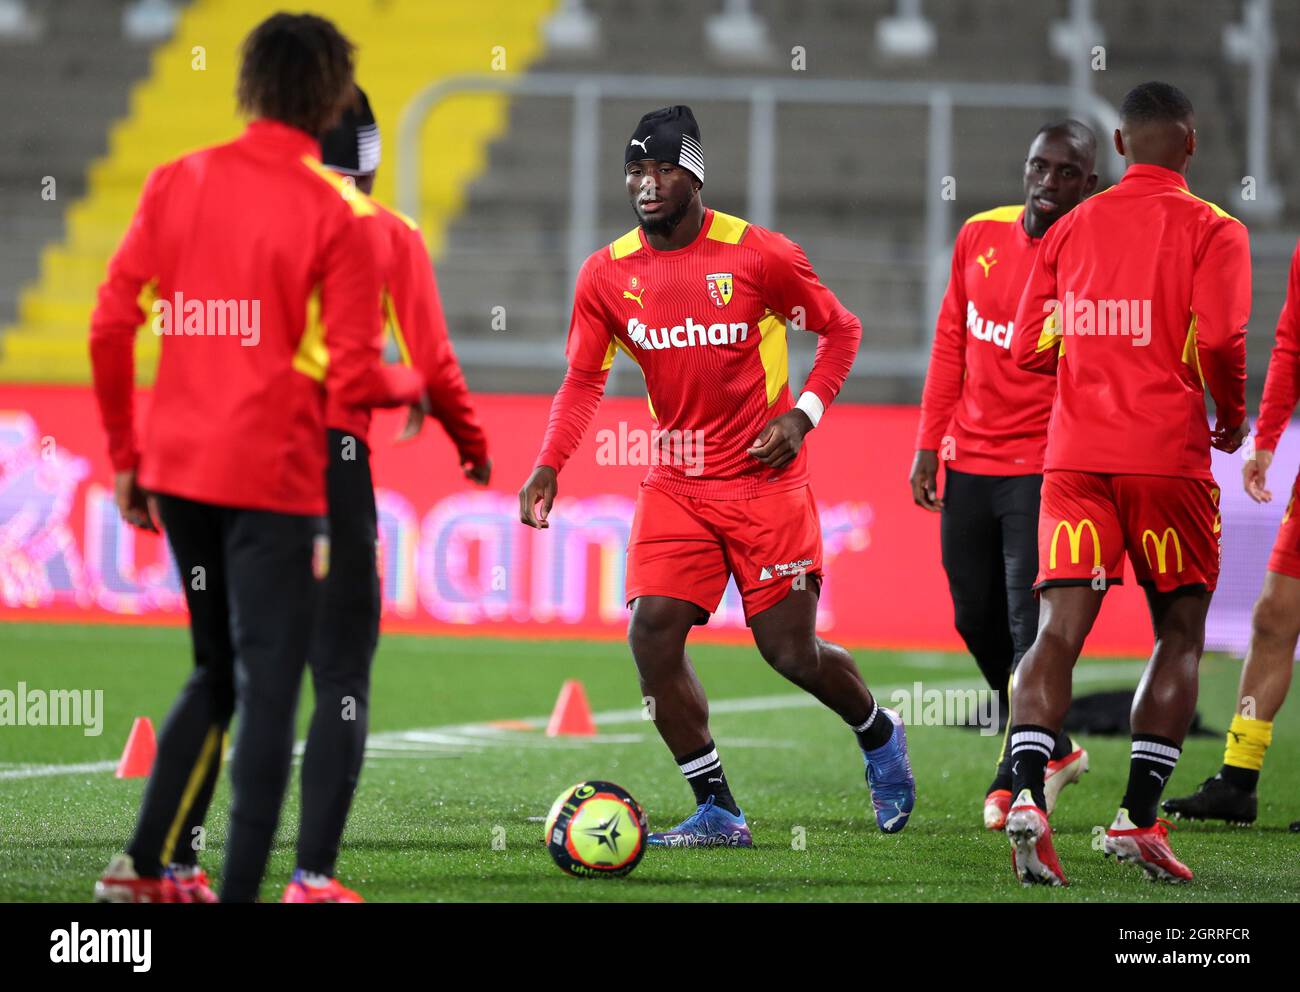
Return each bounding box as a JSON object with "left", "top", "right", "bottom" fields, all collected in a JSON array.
[{"left": 1006, "top": 82, "right": 1251, "bottom": 885}]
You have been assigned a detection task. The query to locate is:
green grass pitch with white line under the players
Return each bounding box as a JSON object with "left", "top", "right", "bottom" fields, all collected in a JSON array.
[{"left": 0, "top": 624, "right": 1300, "bottom": 902}]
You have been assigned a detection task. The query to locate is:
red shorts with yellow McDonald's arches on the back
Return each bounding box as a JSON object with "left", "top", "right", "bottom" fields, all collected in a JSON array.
[{"left": 1034, "top": 471, "right": 1221, "bottom": 593}]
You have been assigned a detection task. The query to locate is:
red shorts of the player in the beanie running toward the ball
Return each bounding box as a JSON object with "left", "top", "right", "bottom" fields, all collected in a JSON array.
[{"left": 627, "top": 484, "right": 822, "bottom": 623}]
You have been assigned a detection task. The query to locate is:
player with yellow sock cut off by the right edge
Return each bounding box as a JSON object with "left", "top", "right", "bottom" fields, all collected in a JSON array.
[{"left": 1164, "top": 243, "right": 1300, "bottom": 829}]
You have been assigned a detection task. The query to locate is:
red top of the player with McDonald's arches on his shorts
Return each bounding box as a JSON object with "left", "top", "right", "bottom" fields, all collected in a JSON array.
[{"left": 1011, "top": 164, "right": 1251, "bottom": 478}]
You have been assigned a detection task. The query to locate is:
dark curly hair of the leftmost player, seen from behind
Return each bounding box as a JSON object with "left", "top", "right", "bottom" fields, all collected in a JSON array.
[{"left": 238, "top": 13, "right": 355, "bottom": 137}]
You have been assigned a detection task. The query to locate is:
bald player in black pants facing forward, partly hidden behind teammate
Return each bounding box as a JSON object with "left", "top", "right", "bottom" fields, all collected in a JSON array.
[{"left": 909, "top": 121, "right": 1097, "bottom": 829}]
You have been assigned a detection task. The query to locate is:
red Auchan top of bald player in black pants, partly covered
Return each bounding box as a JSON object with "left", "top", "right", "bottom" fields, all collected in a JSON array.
[{"left": 917, "top": 205, "right": 1056, "bottom": 476}]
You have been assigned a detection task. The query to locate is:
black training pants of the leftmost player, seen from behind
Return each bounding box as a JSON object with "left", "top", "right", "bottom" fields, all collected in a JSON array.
[{"left": 127, "top": 495, "right": 324, "bottom": 902}]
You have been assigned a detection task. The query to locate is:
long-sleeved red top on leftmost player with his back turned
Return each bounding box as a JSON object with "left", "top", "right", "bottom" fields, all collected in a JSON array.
[{"left": 90, "top": 120, "right": 421, "bottom": 514}]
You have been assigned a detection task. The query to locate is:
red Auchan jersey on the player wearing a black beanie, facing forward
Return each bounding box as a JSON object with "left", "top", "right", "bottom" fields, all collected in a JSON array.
[{"left": 538, "top": 211, "right": 862, "bottom": 499}]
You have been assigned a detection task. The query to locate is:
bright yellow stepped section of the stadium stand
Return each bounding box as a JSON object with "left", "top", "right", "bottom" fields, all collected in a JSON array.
[{"left": 0, "top": 0, "right": 553, "bottom": 381}]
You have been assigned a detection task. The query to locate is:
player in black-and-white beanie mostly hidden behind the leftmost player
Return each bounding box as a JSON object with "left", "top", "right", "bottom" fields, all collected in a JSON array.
[{"left": 158, "top": 87, "right": 491, "bottom": 902}]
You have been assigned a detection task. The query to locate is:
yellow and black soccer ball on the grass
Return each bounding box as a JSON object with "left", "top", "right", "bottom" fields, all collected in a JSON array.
[{"left": 542, "top": 781, "right": 646, "bottom": 878}]
